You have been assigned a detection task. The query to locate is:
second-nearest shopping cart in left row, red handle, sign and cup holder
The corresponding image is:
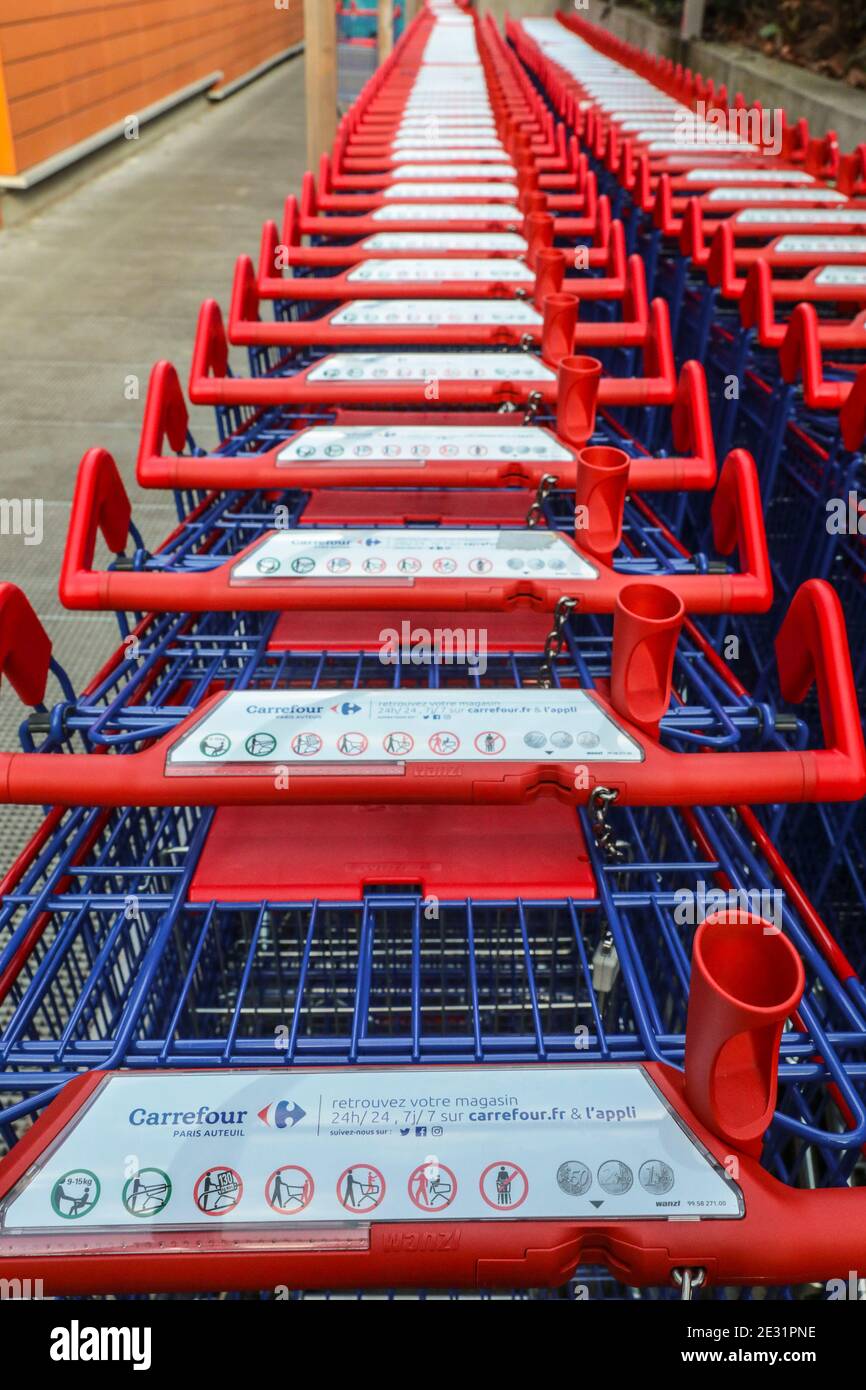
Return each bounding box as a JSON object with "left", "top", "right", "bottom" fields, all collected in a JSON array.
[{"left": 0, "top": 581, "right": 866, "bottom": 809}]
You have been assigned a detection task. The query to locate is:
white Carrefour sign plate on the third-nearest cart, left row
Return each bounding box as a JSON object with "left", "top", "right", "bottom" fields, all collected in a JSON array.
[{"left": 232, "top": 527, "right": 598, "bottom": 584}]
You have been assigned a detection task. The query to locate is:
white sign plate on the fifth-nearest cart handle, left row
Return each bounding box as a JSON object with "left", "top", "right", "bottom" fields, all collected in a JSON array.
[{"left": 307, "top": 352, "right": 556, "bottom": 382}]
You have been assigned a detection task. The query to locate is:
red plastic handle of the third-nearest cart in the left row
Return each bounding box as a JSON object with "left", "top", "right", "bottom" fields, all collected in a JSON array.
[{"left": 60, "top": 447, "right": 773, "bottom": 613}]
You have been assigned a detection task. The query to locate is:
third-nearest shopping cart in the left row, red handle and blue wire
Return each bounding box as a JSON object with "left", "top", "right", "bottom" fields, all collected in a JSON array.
[{"left": 60, "top": 430, "right": 771, "bottom": 613}]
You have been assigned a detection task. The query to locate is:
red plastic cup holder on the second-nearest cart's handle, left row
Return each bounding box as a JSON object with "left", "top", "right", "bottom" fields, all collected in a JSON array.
[{"left": 610, "top": 584, "right": 685, "bottom": 734}]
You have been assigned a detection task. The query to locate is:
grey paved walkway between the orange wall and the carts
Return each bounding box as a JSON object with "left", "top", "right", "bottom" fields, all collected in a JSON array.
[{"left": 0, "top": 58, "right": 306, "bottom": 850}]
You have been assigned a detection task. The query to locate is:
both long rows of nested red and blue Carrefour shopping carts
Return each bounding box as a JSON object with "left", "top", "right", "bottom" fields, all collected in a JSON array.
[{"left": 0, "top": 0, "right": 866, "bottom": 1297}]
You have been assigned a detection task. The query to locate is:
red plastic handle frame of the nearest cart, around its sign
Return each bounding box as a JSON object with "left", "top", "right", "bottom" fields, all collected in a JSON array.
[{"left": 0, "top": 1063, "right": 866, "bottom": 1295}]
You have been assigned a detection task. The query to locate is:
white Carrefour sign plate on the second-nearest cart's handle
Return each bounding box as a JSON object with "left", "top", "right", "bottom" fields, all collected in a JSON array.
[{"left": 165, "top": 686, "right": 644, "bottom": 774}]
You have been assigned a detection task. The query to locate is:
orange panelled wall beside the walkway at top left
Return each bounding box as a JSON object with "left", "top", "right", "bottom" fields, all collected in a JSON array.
[{"left": 0, "top": 0, "right": 303, "bottom": 174}]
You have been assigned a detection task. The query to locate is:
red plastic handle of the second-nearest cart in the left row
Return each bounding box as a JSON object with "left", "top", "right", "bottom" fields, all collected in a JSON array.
[{"left": 0, "top": 580, "right": 866, "bottom": 806}]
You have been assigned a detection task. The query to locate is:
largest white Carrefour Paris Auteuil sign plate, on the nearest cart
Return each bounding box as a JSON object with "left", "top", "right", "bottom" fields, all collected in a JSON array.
[{"left": 0, "top": 1065, "right": 745, "bottom": 1234}]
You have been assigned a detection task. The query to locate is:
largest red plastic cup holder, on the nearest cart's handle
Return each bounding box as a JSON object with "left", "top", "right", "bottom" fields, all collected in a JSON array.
[{"left": 685, "top": 912, "right": 806, "bottom": 1154}]
